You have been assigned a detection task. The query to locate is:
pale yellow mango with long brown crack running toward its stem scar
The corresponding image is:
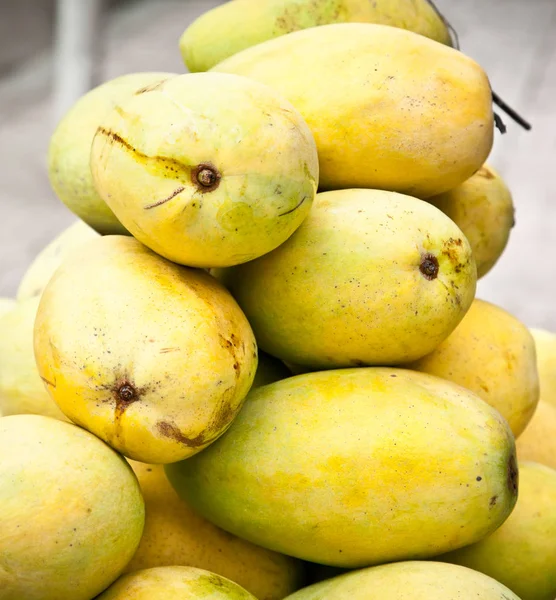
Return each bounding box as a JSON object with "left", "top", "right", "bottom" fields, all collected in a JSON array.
[{"left": 91, "top": 73, "right": 318, "bottom": 268}]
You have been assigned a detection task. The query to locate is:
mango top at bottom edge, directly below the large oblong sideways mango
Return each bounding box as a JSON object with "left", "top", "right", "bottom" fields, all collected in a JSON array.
[{"left": 286, "top": 561, "right": 520, "bottom": 600}]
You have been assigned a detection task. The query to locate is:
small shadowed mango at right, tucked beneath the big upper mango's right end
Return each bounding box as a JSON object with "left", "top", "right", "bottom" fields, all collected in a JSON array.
[{"left": 428, "top": 165, "right": 515, "bottom": 278}]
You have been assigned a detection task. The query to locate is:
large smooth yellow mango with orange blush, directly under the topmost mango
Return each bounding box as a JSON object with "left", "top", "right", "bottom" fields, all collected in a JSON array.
[{"left": 211, "top": 23, "right": 494, "bottom": 198}]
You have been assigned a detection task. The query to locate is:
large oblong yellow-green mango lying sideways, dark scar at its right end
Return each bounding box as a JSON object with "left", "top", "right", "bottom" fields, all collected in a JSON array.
[{"left": 166, "top": 368, "right": 517, "bottom": 568}]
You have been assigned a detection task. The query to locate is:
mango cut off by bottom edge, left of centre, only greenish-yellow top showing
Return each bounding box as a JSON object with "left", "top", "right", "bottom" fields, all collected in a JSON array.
[{"left": 96, "top": 567, "right": 257, "bottom": 600}]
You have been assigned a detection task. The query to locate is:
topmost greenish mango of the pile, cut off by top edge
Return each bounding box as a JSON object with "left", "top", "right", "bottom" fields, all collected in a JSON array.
[{"left": 180, "top": 0, "right": 452, "bottom": 72}]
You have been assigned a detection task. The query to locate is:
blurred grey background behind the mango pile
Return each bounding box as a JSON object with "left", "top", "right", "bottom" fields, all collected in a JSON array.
[{"left": 0, "top": 0, "right": 556, "bottom": 331}]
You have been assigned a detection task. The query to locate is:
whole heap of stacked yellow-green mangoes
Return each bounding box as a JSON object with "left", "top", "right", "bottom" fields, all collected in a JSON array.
[{"left": 0, "top": 0, "right": 556, "bottom": 600}]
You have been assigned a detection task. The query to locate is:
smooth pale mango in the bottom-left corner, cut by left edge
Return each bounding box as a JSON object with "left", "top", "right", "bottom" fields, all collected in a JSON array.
[{"left": 0, "top": 415, "right": 145, "bottom": 600}]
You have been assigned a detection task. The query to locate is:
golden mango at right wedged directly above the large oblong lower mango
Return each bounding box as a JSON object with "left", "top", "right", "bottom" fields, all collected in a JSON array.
[{"left": 407, "top": 299, "right": 539, "bottom": 438}]
